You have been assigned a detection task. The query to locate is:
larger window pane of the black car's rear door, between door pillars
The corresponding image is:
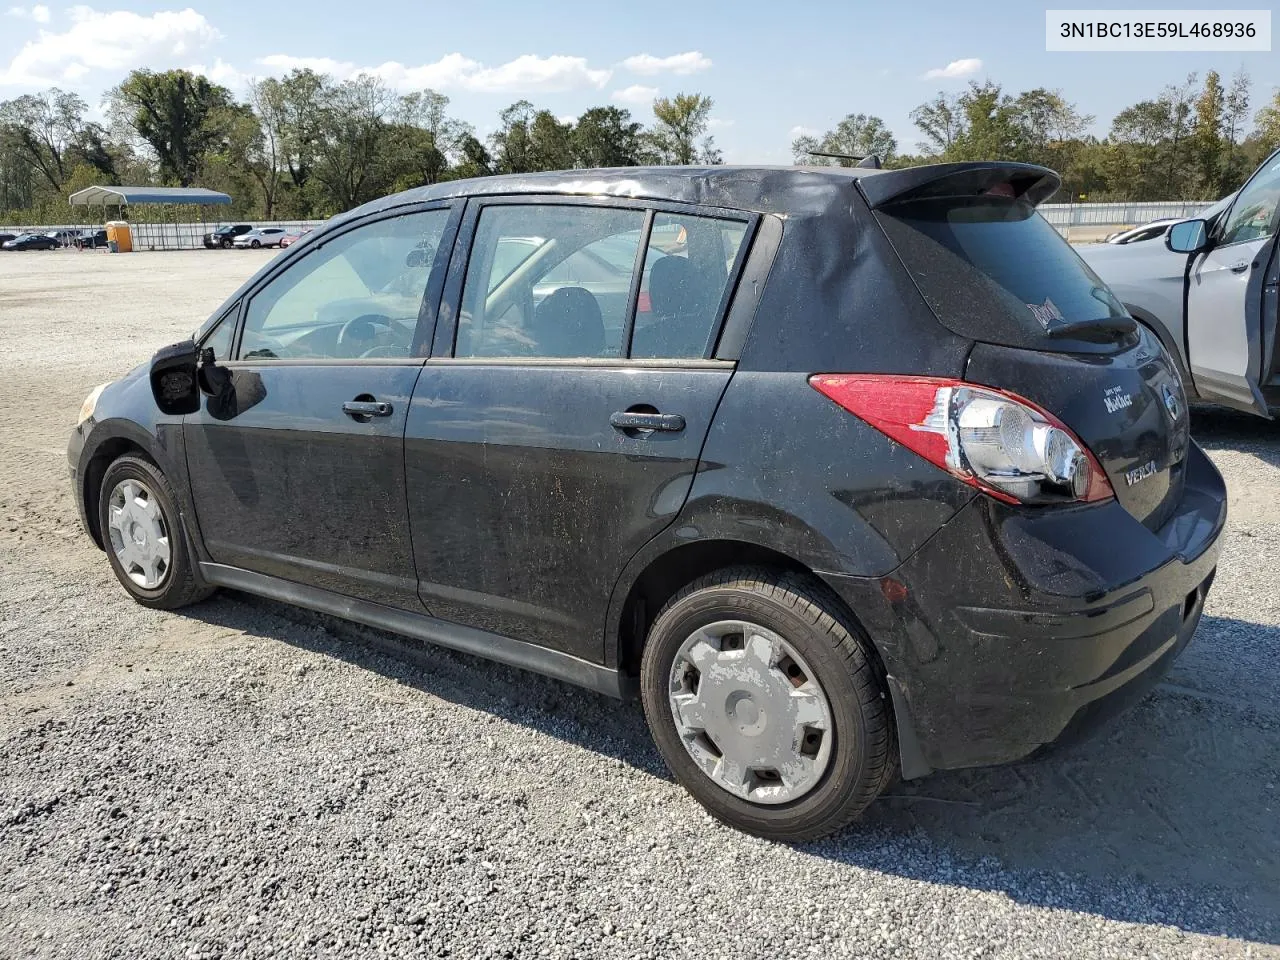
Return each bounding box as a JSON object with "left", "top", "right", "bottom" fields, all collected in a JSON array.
[{"left": 454, "top": 204, "right": 645, "bottom": 357}]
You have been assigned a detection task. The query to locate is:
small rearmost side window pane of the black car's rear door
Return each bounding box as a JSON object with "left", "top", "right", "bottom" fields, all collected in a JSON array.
[{"left": 631, "top": 214, "right": 746, "bottom": 360}]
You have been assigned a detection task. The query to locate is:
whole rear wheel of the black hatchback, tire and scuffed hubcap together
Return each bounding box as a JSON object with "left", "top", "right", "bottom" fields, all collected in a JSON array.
[{"left": 640, "top": 568, "right": 897, "bottom": 841}]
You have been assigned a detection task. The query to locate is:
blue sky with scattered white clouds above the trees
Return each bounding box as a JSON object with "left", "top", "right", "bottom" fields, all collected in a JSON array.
[{"left": 0, "top": 0, "right": 1280, "bottom": 163}]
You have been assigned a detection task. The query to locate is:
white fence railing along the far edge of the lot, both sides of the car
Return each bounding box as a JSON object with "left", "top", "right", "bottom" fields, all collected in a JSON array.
[{"left": 0, "top": 200, "right": 1213, "bottom": 250}]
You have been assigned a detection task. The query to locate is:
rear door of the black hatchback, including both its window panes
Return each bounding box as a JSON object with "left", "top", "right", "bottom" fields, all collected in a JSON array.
[{"left": 406, "top": 198, "right": 754, "bottom": 662}]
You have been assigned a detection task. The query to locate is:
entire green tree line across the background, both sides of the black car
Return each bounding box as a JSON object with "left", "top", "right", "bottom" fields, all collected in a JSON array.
[{"left": 0, "top": 69, "right": 1280, "bottom": 223}]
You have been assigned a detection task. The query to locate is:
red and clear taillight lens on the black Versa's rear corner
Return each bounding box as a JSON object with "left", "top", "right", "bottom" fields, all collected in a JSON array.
[{"left": 809, "top": 374, "right": 1115, "bottom": 503}]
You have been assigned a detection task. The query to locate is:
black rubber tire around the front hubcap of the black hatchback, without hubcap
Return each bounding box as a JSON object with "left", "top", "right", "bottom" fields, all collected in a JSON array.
[{"left": 97, "top": 456, "right": 214, "bottom": 611}]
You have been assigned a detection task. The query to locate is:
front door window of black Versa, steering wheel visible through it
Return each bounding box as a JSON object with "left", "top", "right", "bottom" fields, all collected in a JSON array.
[{"left": 239, "top": 210, "right": 449, "bottom": 360}]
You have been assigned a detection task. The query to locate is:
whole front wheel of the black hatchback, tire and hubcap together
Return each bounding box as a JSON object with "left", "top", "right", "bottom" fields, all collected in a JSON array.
[{"left": 99, "top": 456, "right": 212, "bottom": 609}]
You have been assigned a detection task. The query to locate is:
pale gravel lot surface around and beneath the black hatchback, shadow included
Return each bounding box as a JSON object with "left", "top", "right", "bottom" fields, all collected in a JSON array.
[{"left": 0, "top": 251, "right": 1280, "bottom": 960}]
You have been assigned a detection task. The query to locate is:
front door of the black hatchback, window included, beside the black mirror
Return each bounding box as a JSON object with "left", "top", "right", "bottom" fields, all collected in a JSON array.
[{"left": 184, "top": 207, "right": 456, "bottom": 609}]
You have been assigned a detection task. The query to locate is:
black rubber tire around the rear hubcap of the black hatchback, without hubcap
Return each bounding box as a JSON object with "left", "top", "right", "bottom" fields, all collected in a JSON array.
[{"left": 640, "top": 567, "right": 899, "bottom": 842}]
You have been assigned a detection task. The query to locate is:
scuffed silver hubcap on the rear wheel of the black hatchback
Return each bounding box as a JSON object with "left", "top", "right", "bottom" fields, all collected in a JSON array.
[{"left": 669, "top": 620, "right": 835, "bottom": 804}]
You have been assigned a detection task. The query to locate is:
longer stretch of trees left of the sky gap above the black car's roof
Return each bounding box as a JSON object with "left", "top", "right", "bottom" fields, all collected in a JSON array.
[{"left": 0, "top": 69, "right": 721, "bottom": 223}]
